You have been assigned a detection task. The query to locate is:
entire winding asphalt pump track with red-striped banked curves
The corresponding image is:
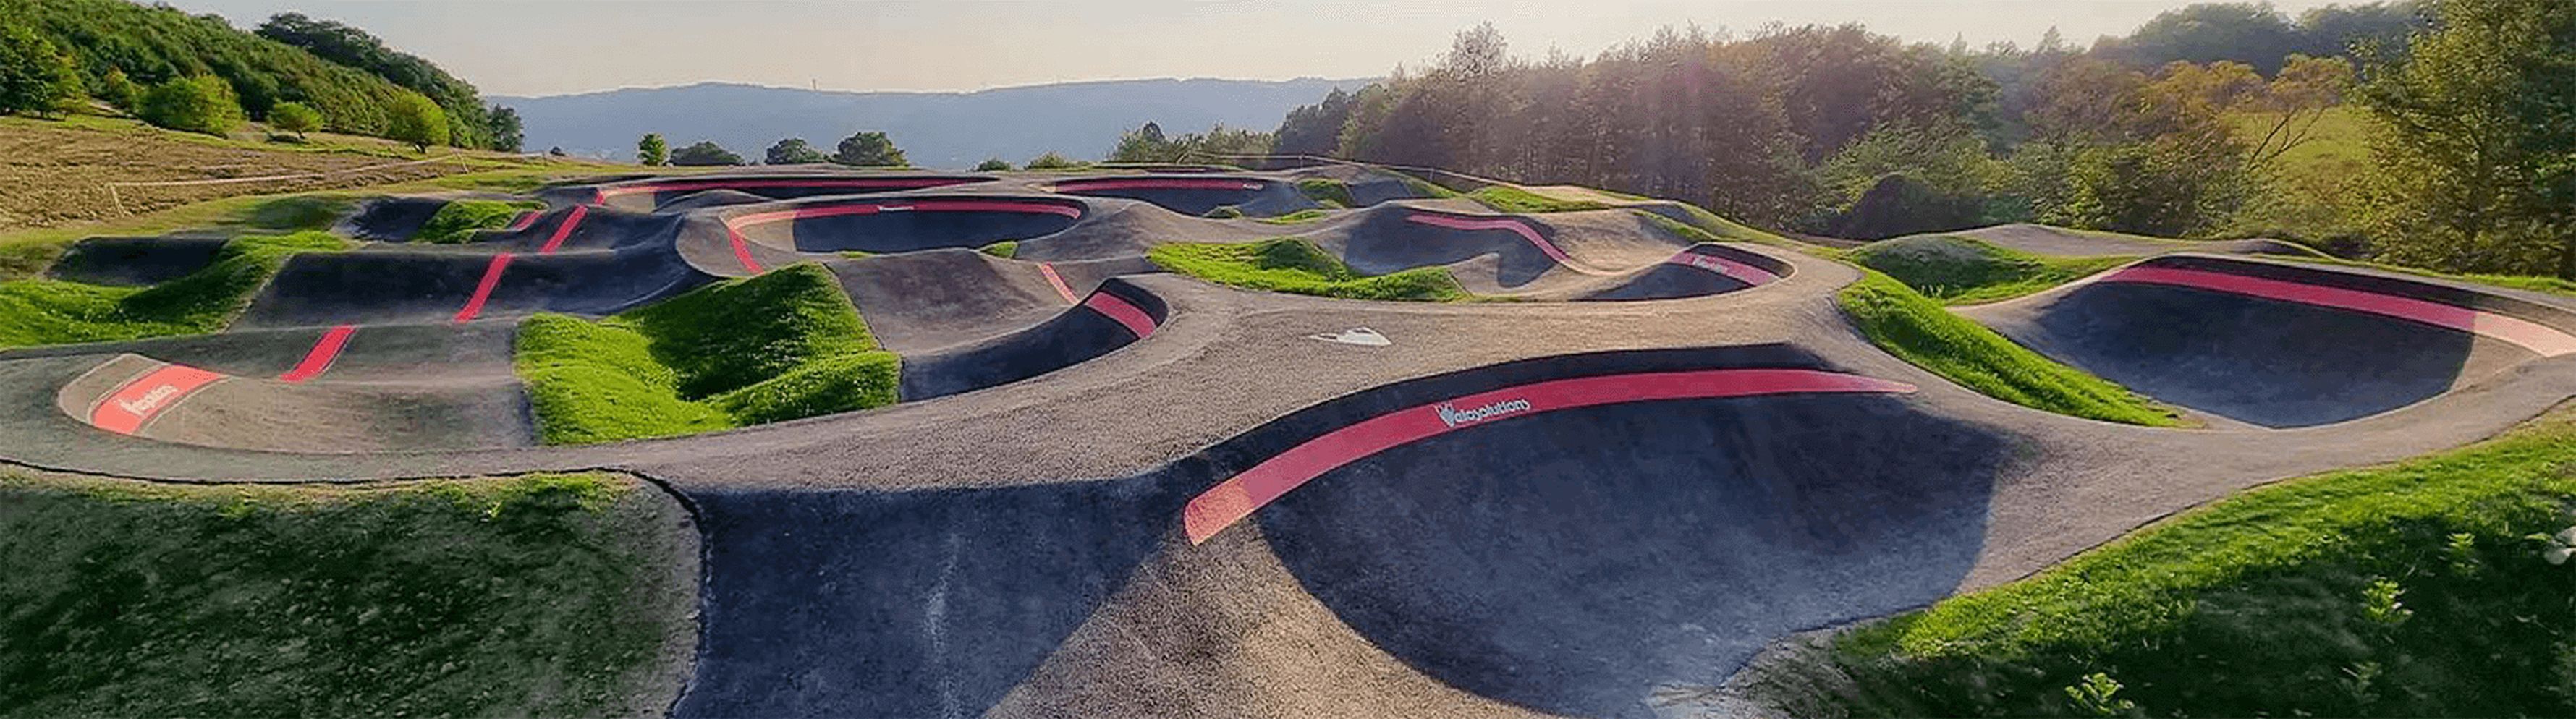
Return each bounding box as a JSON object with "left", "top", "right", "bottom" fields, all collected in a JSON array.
[{"left": 0, "top": 165, "right": 2576, "bottom": 716}]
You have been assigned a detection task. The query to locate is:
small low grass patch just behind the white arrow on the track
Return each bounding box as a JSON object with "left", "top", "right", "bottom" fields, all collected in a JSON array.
[{"left": 1146, "top": 237, "right": 1473, "bottom": 302}]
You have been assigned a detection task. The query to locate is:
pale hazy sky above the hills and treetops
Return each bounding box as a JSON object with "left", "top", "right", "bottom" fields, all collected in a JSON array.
[{"left": 151, "top": 0, "right": 2326, "bottom": 95}]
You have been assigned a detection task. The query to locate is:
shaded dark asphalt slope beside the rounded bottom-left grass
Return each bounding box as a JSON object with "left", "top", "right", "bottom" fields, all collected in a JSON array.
[{"left": 672, "top": 480, "right": 1187, "bottom": 716}]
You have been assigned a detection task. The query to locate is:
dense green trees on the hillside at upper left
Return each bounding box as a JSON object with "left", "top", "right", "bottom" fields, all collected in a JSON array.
[{"left": 0, "top": 0, "right": 523, "bottom": 152}]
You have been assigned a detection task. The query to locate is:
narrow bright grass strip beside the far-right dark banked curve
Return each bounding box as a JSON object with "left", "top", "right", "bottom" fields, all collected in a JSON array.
[{"left": 1836, "top": 271, "right": 2182, "bottom": 427}]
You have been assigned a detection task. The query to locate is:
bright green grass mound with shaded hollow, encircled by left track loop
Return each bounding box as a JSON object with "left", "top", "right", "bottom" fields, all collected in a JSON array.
[{"left": 515, "top": 263, "right": 902, "bottom": 443}]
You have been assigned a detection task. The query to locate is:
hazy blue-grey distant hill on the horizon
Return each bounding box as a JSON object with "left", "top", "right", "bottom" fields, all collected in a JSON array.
[{"left": 487, "top": 77, "right": 1368, "bottom": 168}]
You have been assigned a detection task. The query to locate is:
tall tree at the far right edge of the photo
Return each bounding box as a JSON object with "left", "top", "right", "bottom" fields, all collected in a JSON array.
[{"left": 2360, "top": 0, "right": 2576, "bottom": 278}]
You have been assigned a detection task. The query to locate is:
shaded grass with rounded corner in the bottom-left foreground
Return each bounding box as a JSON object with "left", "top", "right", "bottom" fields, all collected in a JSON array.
[{"left": 0, "top": 472, "right": 698, "bottom": 716}]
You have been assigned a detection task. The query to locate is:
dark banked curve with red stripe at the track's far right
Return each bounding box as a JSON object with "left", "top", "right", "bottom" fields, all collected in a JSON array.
[{"left": 1970, "top": 255, "right": 2576, "bottom": 427}]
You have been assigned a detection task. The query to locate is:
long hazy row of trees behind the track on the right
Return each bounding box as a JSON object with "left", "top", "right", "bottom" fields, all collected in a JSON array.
[{"left": 1273, "top": 0, "right": 2576, "bottom": 276}]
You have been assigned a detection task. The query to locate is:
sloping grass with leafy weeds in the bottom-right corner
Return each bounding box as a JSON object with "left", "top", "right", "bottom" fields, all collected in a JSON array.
[{"left": 1806, "top": 409, "right": 2576, "bottom": 716}]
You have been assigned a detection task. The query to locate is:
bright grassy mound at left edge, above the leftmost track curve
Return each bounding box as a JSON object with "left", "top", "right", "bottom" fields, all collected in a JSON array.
[{"left": 0, "top": 232, "right": 350, "bottom": 348}]
